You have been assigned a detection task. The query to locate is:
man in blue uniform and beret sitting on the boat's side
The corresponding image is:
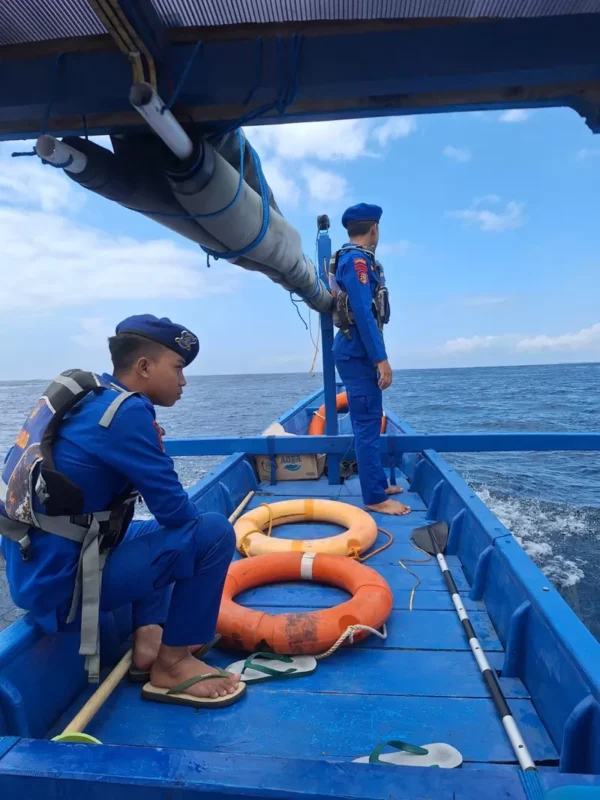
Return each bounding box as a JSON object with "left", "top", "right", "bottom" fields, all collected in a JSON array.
[{"left": 0, "top": 314, "right": 245, "bottom": 705}]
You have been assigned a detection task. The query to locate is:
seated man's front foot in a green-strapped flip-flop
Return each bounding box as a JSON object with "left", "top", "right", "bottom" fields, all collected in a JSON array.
[{"left": 150, "top": 645, "right": 240, "bottom": 698}]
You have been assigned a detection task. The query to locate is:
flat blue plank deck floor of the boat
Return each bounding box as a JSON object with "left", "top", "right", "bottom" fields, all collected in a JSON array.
[{"left": 49, "top": 478, "right": 558, "bottom": 768}]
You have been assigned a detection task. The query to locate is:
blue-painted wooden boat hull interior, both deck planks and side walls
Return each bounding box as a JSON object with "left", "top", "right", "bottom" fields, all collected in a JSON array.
[{"left": 0, "top": 392, "right": 600, "bottom": 800}]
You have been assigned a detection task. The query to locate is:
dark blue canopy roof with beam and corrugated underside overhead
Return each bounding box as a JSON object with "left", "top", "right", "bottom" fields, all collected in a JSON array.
[{"left": 0, "top": 0, "right": 600, "bottom": 139}]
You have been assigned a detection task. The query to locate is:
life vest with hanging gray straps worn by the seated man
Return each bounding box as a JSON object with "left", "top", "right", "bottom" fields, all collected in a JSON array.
[{"left": 0, "top": 369, "right": 139, "bottom": 681}]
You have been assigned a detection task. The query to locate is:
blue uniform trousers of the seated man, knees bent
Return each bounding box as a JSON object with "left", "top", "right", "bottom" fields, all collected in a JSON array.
[{"left": 58, "top": 513, "right": 235, "bottom": 647}]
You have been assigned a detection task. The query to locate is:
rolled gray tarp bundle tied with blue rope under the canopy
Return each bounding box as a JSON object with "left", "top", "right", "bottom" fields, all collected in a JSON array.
[{"left": 63, "top": 130, "right": 332, "bottom": 311}]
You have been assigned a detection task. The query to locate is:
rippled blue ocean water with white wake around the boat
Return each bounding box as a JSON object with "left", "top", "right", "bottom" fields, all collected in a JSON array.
[{"left": 0, "top": 364, "right": 600, "bottom": 639}]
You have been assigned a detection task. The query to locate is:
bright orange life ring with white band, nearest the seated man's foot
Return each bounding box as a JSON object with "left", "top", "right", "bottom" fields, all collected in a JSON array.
[{"left": 217, "top": 553, "right": 393, "bottom": 655}]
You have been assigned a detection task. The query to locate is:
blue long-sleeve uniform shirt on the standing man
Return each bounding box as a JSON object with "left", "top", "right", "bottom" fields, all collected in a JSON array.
[{"left": 333, "top": 245, "right": 387, "bottom": 364}]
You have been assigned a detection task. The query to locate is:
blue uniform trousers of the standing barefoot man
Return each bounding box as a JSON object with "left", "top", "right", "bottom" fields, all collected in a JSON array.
[{"left": 335, "top": 354, "right": 388, "bottom": 505}]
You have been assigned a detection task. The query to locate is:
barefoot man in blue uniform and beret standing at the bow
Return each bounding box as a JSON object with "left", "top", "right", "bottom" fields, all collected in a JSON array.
[{"left": 330, "top": 203, "right": 410, "bottom": 515}]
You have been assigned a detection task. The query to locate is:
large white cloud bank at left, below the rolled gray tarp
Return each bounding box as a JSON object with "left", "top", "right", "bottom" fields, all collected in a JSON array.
[{"left": 0, "top": 150, "right": 238, "bottom": 316}]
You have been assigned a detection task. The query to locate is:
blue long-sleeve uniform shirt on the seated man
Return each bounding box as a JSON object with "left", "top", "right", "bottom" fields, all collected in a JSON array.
[{"left": 2, "top": 375, "right": 200, "bottom": 631}]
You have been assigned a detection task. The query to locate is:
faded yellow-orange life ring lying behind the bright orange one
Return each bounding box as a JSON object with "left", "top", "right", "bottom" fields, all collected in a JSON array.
[{"left": 233, "top": 500, "right": 377, "bottom": 557}]
